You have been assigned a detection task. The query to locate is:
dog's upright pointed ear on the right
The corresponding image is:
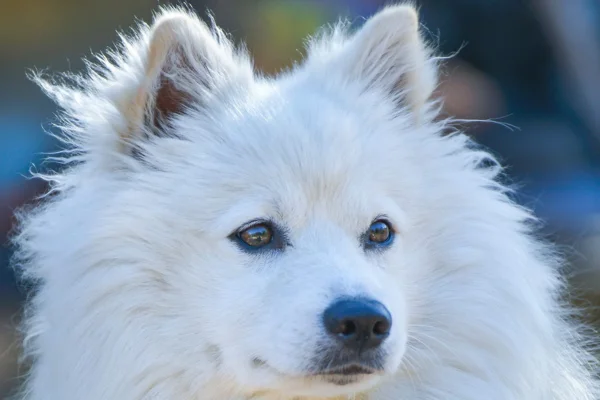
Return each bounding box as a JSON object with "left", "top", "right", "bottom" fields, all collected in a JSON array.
[{"left": 309, "top": 4, "right": 437, "bottom": 119}]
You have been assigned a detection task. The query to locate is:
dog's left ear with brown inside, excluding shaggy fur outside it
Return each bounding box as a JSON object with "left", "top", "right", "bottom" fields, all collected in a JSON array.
[{"left": 120, "top": 10, "right": 253, "bottom": 141}]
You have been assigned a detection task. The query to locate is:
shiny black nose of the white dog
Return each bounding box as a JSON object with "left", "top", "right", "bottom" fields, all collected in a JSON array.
[{"left": 323, "top": 298, "right": 392, "bottom": 351}]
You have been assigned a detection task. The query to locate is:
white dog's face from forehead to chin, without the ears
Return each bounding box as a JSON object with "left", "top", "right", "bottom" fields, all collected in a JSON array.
[{"left": 158, "top": 85, "right": 416, "bottom": 395}]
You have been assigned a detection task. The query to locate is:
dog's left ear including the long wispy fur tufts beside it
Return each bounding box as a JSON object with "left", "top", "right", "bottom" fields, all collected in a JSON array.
[{"left": 32, "top": 8, "right": 254, "bottom": 162}]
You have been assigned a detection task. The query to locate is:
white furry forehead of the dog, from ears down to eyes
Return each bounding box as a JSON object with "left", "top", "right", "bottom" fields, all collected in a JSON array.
[{"left": 180, "top": 96, "right": 410, "bottom": 229}]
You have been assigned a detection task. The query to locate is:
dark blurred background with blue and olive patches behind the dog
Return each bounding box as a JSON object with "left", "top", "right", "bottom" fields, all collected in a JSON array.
[{"left": 0, "top": 0, "right": 600, "bottom": 398}]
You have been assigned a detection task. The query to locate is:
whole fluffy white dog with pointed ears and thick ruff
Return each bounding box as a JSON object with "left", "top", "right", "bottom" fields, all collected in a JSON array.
[{"left": 15, "top": 5, "right": 598, "bottom": 400}]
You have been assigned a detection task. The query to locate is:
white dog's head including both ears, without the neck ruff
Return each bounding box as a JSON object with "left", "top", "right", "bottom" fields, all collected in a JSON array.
[{"left": 29, "top": 6, "right": 442, "bottom": 396}]
